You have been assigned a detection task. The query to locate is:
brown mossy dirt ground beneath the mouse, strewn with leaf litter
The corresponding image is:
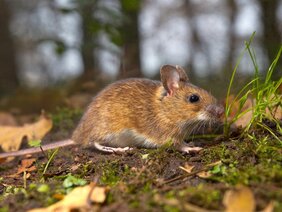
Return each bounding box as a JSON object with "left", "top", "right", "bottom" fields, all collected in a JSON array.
[{"left": 0, "top": 115, "right": 282, "bottom": 211}]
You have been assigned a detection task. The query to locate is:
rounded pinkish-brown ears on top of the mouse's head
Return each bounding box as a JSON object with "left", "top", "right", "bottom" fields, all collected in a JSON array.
[{"left": 160, "top": 65, "right": 188, "bottom": 96}]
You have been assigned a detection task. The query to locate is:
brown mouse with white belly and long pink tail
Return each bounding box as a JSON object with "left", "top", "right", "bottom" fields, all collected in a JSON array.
[{"left": 0, "top": 65, "right": 224, "bottom": 158}]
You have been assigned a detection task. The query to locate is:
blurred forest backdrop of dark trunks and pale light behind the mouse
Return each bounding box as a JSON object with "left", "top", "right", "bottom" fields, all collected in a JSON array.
[{"left": 0, "top": 0, "right": 282, "bottom": 111}]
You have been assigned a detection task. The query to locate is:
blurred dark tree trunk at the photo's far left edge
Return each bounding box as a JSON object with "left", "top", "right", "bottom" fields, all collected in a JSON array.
[{"left": 0, "top": 0, "right": 19, "bottom": 95}]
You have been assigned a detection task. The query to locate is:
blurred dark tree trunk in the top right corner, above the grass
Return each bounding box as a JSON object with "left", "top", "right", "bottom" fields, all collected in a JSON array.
[{"left": 258, "top": 0, "right": 282, "bottom": 79}]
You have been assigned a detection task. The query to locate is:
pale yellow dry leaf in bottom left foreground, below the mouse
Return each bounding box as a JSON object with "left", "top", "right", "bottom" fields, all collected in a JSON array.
[{"left": 30, "top": 184, "right": 107, "bottom": 212}]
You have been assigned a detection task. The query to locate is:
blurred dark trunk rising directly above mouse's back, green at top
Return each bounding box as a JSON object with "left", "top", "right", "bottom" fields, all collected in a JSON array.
[{"left": 119, "top": 0, "right": 142, "bottom": 78}]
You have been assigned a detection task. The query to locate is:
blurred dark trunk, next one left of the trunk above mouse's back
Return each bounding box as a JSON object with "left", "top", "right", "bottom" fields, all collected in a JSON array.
[{"left": 80, "top": 1, "right": 100, "bottom": 80}]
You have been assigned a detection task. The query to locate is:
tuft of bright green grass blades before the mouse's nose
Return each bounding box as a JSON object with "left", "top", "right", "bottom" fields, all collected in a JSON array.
[{"left": 224, "top": 33, "right": 282, "bottom": 144}]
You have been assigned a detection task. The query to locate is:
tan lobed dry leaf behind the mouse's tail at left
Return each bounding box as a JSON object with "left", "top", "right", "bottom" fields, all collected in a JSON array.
[{"left": 0, "top": 116, "right": 52, "bottom": 152}]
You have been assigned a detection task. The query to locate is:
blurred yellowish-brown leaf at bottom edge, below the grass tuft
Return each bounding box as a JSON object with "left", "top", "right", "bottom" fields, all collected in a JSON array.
[{"left": 223, "top": 185, "right": 256, "bottom": 212}]
